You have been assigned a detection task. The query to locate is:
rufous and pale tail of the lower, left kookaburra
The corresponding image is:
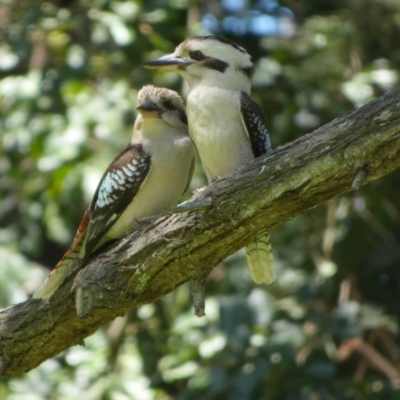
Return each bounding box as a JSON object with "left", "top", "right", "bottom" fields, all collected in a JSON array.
[{"left": 32, "top": 210, "right": 90, "bottom": 299}]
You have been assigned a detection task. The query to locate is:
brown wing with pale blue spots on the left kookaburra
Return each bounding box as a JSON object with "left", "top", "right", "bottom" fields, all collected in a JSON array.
[{"left": 85, "top": 144, "right": 151, "bottom": 256}]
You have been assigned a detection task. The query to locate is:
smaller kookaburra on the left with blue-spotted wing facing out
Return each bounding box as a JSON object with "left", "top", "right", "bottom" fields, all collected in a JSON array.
[{"left": 33, "top": 85, "right": 194, "bottom": 298}]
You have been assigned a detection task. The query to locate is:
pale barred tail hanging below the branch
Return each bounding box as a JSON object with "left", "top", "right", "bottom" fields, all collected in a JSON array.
[{"left": 246, "top": 234, "right": 275, "bottom": 284}]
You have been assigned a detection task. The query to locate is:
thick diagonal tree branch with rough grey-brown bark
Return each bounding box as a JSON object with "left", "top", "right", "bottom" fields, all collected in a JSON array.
[{"left": 0, "top": 88, "right": 400, "bottom": 376}]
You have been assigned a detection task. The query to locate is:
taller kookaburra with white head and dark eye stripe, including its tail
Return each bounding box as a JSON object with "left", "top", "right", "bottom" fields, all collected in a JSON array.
[{"left": 143, "top": 36, "right": 275, "bottom": 283}]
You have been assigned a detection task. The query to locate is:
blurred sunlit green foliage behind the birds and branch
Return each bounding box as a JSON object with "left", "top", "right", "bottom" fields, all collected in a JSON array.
[{"left": 0, "top": 0, "right": 400, "bottom": 400}]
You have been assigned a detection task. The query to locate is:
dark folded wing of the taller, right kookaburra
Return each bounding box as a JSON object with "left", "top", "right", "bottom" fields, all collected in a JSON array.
[{"left": 240, "top": 92, "right": 271, "bottom": 157}]
